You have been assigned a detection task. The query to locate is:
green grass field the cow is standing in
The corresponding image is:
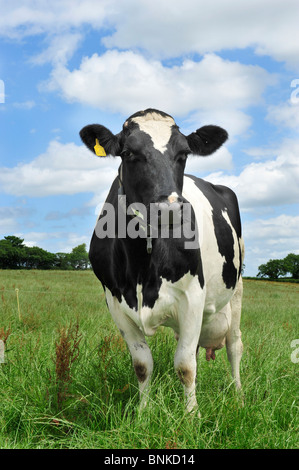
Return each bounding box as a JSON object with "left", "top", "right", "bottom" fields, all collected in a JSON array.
[{"left": 0, "top": 271, "right": 299, "bottom": 449}]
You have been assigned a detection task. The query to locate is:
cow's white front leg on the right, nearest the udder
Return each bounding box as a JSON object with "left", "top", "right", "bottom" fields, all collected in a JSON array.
[{"left": 174, "top": 296, "right": 202, "bottom": 416}]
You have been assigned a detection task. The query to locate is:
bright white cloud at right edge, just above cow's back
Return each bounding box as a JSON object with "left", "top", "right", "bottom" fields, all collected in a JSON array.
[{"left": 207, "top": 140, "right": 299, "bottom": 210}]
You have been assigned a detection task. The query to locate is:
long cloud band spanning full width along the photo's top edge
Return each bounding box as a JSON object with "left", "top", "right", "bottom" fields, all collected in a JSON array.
[{"left": 0, "top": 0, "right": 299, "bottom": 70}]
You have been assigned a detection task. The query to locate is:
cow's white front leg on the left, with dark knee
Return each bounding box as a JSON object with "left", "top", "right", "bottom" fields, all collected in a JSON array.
[{"left": 106, "top": 289, "right": 153, "bottom": 409}]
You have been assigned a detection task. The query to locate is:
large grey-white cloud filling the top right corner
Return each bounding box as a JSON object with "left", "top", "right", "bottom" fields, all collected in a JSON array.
[{"left": 104, "top": 0, "right": 299, "bottom": 69}]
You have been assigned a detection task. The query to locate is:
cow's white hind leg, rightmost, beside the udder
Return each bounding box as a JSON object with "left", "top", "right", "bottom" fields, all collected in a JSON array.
[{"left": 226, "top": 277, "right": 243, "bottom": 389}]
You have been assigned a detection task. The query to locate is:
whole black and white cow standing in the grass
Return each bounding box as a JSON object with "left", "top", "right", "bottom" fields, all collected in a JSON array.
[{"left": 80, "top": 109, "right": 244, "bottom": 411}]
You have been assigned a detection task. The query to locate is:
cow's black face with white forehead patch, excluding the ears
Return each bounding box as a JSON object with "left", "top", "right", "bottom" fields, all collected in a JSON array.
[{"left": 121, "top": 113, "right": 191, "bottom": 207}]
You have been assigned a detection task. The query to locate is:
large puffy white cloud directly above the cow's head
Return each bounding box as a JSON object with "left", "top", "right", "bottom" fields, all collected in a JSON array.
[{"left": 42, "top": 50, "right": 275, "bottom": 133}]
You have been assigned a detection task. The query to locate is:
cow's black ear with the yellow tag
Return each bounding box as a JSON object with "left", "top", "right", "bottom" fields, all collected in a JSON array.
[{"left": 80, "top": 124, "right": 121, "bottom": 157}]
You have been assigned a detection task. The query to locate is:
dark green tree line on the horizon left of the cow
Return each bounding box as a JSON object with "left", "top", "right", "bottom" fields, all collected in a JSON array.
[{"left": 0, "top": 235, "right": 90, "bottom": 269}]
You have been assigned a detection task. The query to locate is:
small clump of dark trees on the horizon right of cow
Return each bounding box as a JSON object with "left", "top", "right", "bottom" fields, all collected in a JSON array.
[{"left": 257, "top": 253, "right": 299, "bottom": 279}]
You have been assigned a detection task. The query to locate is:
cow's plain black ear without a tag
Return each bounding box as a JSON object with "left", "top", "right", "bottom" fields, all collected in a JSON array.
[{"left": 187, "top": 126, "right": 228, "bottom": 156}]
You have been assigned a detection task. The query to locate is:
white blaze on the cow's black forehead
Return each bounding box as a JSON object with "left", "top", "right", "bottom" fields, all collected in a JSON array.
[{"left": 132, "top": 113, "right": 175, "bottom": 153}]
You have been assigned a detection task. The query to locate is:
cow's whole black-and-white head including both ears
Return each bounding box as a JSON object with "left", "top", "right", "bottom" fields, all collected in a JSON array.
[{"left": 80, "top": 109, "right": 228, "bottom": 213}]
